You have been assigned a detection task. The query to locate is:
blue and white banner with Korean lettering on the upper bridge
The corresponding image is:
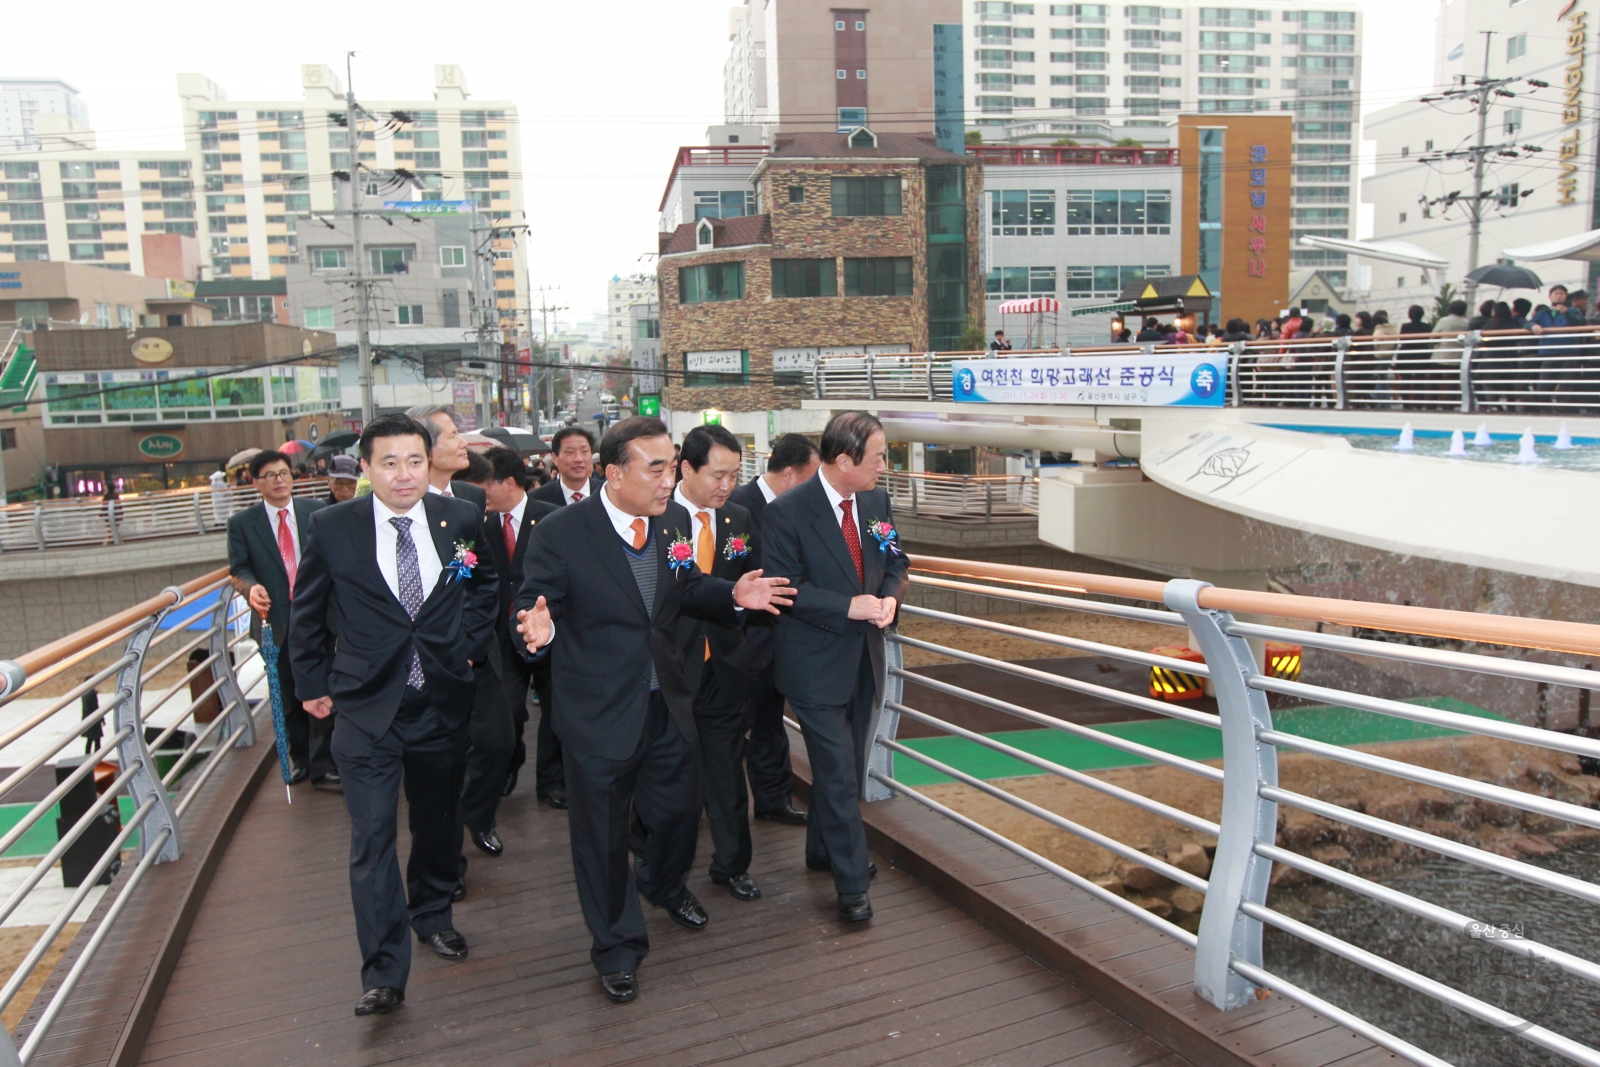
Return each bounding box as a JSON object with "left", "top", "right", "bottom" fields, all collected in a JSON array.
[{"left": 950, "top": 349, "right": 1227, "bottom": 408}]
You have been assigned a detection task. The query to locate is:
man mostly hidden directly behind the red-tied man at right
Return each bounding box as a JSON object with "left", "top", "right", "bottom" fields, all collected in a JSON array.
[{"left": 728, "top": 434, "right": 822, "bottom": 825}]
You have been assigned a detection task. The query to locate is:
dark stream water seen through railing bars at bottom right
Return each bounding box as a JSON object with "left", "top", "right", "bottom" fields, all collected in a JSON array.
[{"left": 1264, "top": 841, "right": 1600, "bottom": 1067}]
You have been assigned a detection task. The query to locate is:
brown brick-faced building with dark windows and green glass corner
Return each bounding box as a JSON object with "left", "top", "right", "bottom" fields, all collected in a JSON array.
[{"left": 658, "top": 130, "right": 984, "bottom": 448}]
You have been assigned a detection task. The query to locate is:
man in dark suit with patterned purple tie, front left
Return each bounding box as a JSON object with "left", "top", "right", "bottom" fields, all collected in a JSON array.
[{"left": 290, "top": 414, "right": 498, "bottom": 1016}]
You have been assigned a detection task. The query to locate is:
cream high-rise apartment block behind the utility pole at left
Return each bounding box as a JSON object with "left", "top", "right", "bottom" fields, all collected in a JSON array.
[{"left": 178, "top": 64, "right": 528, "bottom": 331}]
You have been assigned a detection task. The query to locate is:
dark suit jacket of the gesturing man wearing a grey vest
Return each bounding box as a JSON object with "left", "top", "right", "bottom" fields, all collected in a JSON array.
[{"left": 517, "top": 496, "right": 739, "bottom": 760}]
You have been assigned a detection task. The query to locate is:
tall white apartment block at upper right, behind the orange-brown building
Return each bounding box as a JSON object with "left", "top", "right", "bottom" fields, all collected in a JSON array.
[{"left": 965, "top": 0, "right": 1356, "bottom": 285}]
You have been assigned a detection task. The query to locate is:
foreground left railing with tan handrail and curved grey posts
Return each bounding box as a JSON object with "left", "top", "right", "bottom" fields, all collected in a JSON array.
[{"left": 0, "top": 568, "right": 261, "bottom": 1065}]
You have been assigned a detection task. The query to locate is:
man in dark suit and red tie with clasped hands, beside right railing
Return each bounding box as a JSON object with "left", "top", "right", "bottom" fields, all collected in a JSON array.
[{"left": 762, "top": 411, "right": 909, "bottom": 921}]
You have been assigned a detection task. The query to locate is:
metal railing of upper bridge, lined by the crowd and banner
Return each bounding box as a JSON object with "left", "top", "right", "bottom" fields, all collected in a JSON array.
[{"left": 811, "top": 326, "right": 1600, "bottom": 414}]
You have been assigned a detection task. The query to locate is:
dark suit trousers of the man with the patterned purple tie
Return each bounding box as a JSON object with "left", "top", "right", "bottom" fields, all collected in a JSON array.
[{"left": 333, "top": 688, "right": 467, "bottom": 989}]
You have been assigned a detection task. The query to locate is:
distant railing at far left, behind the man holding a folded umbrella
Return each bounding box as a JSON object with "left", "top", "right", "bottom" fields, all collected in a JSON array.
[{"left": 0, "top": 478, "right": 328, "bottom": 553}]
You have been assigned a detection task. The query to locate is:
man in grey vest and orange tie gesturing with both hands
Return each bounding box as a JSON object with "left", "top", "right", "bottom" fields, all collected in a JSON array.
[{"left": 517, "top": 418, "right": 789, "bottom": 1003}]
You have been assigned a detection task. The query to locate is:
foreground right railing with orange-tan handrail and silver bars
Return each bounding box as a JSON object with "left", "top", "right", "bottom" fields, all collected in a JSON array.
[{"left": 864, "top": 557, "right": 1600, "bottom": 1065}]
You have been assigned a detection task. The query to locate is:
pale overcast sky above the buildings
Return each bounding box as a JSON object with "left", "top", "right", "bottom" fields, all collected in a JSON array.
[{"left": 9, "top": 0, "right": 1438, "bottom": 334}]
